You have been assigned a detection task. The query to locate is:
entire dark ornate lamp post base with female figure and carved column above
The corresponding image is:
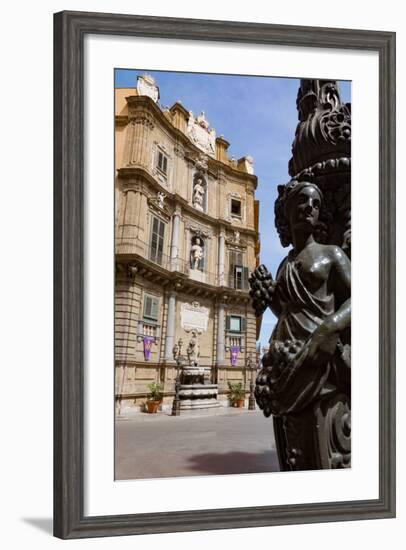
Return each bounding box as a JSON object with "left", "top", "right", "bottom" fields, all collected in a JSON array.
[{"left": 249, "top": 79, "right": 351, "bottom": 471}]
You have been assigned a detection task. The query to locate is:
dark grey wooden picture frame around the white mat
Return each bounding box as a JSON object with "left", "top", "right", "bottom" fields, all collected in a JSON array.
[{"left": 54, "top": 12, "right": 395, "bottom": 539}]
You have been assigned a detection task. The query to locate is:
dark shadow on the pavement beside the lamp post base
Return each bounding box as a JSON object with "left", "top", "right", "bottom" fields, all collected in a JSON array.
[{"left": 189, "top": 450, "right": 280, "bottom": 475}]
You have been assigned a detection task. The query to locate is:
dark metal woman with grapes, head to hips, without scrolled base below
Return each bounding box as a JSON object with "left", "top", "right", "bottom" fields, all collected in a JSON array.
[{"left": 250, "top": 182, "right": 351, "bottom": 416}]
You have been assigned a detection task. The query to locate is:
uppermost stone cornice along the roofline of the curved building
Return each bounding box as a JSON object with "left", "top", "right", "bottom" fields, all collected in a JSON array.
[{"left": 116, "top": 96, "right": 258, "bottom": 190}]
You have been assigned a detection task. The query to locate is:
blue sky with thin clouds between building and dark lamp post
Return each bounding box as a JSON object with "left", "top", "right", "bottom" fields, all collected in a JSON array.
[{"left": 115, "top": 68, "right": 351, "bottom": 346}]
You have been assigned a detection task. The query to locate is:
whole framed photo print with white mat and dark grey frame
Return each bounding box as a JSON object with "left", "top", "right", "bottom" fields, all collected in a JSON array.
[{"left": 54, "top": 12, "right": 395, "bottom": 538}]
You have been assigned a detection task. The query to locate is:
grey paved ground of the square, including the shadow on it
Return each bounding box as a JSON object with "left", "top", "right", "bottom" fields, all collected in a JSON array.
[{"left": 115, "top": 409, "right": 279, "bottom": 479}]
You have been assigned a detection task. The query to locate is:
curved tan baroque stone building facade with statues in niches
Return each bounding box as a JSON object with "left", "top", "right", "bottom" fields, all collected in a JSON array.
[{"left": 115, "top": 75, "right": 259, "bottom": 415}]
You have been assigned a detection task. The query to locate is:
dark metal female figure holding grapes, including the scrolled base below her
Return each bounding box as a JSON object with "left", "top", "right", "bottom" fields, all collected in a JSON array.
[{"left": 250, "top": 179, "right": 351, "bottom": 470}]
